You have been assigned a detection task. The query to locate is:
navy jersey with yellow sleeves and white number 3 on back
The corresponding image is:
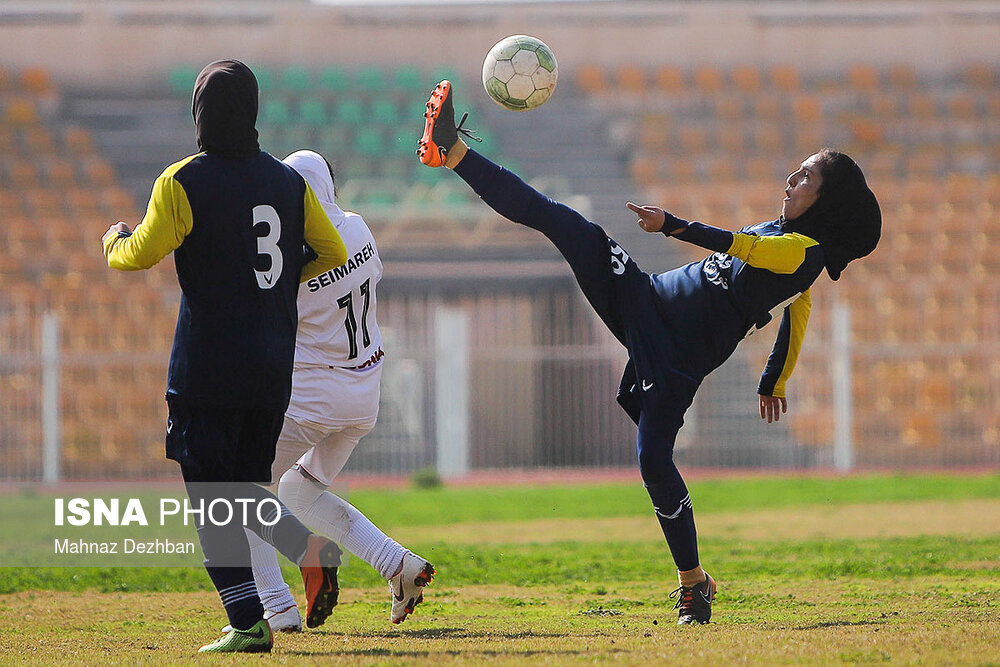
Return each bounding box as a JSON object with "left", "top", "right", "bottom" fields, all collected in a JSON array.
[{"left": 104, "top": 151, "right": 346, "bottom": 409}]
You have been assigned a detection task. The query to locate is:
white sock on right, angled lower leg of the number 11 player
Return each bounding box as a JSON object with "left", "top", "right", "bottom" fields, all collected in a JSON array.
[{"left": 278, "top": 469, "right": 407, "bottom": 579}]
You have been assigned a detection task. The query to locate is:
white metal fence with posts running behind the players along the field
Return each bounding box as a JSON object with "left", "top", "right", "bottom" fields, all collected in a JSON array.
[{"left": 0, "top": 280, "right": 1000, "bottom": 481}]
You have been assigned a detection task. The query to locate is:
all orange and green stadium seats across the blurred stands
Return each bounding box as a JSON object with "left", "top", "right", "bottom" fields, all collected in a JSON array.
[{"left": 0, "top": 58, "right": 1000, "bottom": 477}]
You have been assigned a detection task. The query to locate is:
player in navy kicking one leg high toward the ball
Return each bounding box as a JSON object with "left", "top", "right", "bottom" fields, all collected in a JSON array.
[{"left": 417, "top": 81, "right": 882, "bottom": 624}]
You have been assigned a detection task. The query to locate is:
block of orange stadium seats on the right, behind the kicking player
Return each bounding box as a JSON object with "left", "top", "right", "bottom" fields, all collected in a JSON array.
[{"left": 576, "top": 64, "right": 1000, "bottom": 465}]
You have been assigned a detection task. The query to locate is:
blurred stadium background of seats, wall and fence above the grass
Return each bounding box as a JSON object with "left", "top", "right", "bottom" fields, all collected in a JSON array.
[{"left": 0, "top": 0, "right": 1000, "bottom": 482}]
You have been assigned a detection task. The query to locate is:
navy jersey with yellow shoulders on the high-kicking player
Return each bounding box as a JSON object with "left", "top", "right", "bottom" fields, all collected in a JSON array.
[{"left": 652, "top": 220, "right": 824, "bottom": 396}]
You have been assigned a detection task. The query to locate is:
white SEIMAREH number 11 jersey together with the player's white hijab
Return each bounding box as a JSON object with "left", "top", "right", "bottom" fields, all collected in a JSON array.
[{"left": 284, "top": 151, "right": 385, "bottom": 425}]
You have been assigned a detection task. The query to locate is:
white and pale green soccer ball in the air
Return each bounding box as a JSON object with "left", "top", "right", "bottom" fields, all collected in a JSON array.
[{"left": 483, "top": 35, "right": 559, "bottom": 111}]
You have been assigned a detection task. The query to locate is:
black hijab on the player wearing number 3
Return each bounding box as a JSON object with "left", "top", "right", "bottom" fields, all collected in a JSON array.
[{"left": 191, "top": 60, "right": 260, "bottom": 158}]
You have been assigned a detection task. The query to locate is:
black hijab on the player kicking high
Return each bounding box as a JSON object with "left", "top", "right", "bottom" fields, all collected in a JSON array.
[{"left": 781, "top": 148, "right": 882, "bottom": 280}]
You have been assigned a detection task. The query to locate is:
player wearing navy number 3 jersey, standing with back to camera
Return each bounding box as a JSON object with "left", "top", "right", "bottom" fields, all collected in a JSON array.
[{"left": 103, "top": 60, "right": 347, "bottom": 653}]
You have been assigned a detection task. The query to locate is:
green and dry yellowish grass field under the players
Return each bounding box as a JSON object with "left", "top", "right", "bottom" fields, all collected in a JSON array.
[{"left": 0, "top": 474, "right": 1000, "bottom": 665}]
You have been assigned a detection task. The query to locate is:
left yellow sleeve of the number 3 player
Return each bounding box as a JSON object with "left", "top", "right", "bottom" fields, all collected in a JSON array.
[{"left": 104, "top": 156, "right": 195, "bottom": 271}]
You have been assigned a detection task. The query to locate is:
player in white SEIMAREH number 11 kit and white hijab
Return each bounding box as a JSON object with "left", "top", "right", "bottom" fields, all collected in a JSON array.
[{"left": 234, "top": 150, "right": 435, "bottom": 632}]
